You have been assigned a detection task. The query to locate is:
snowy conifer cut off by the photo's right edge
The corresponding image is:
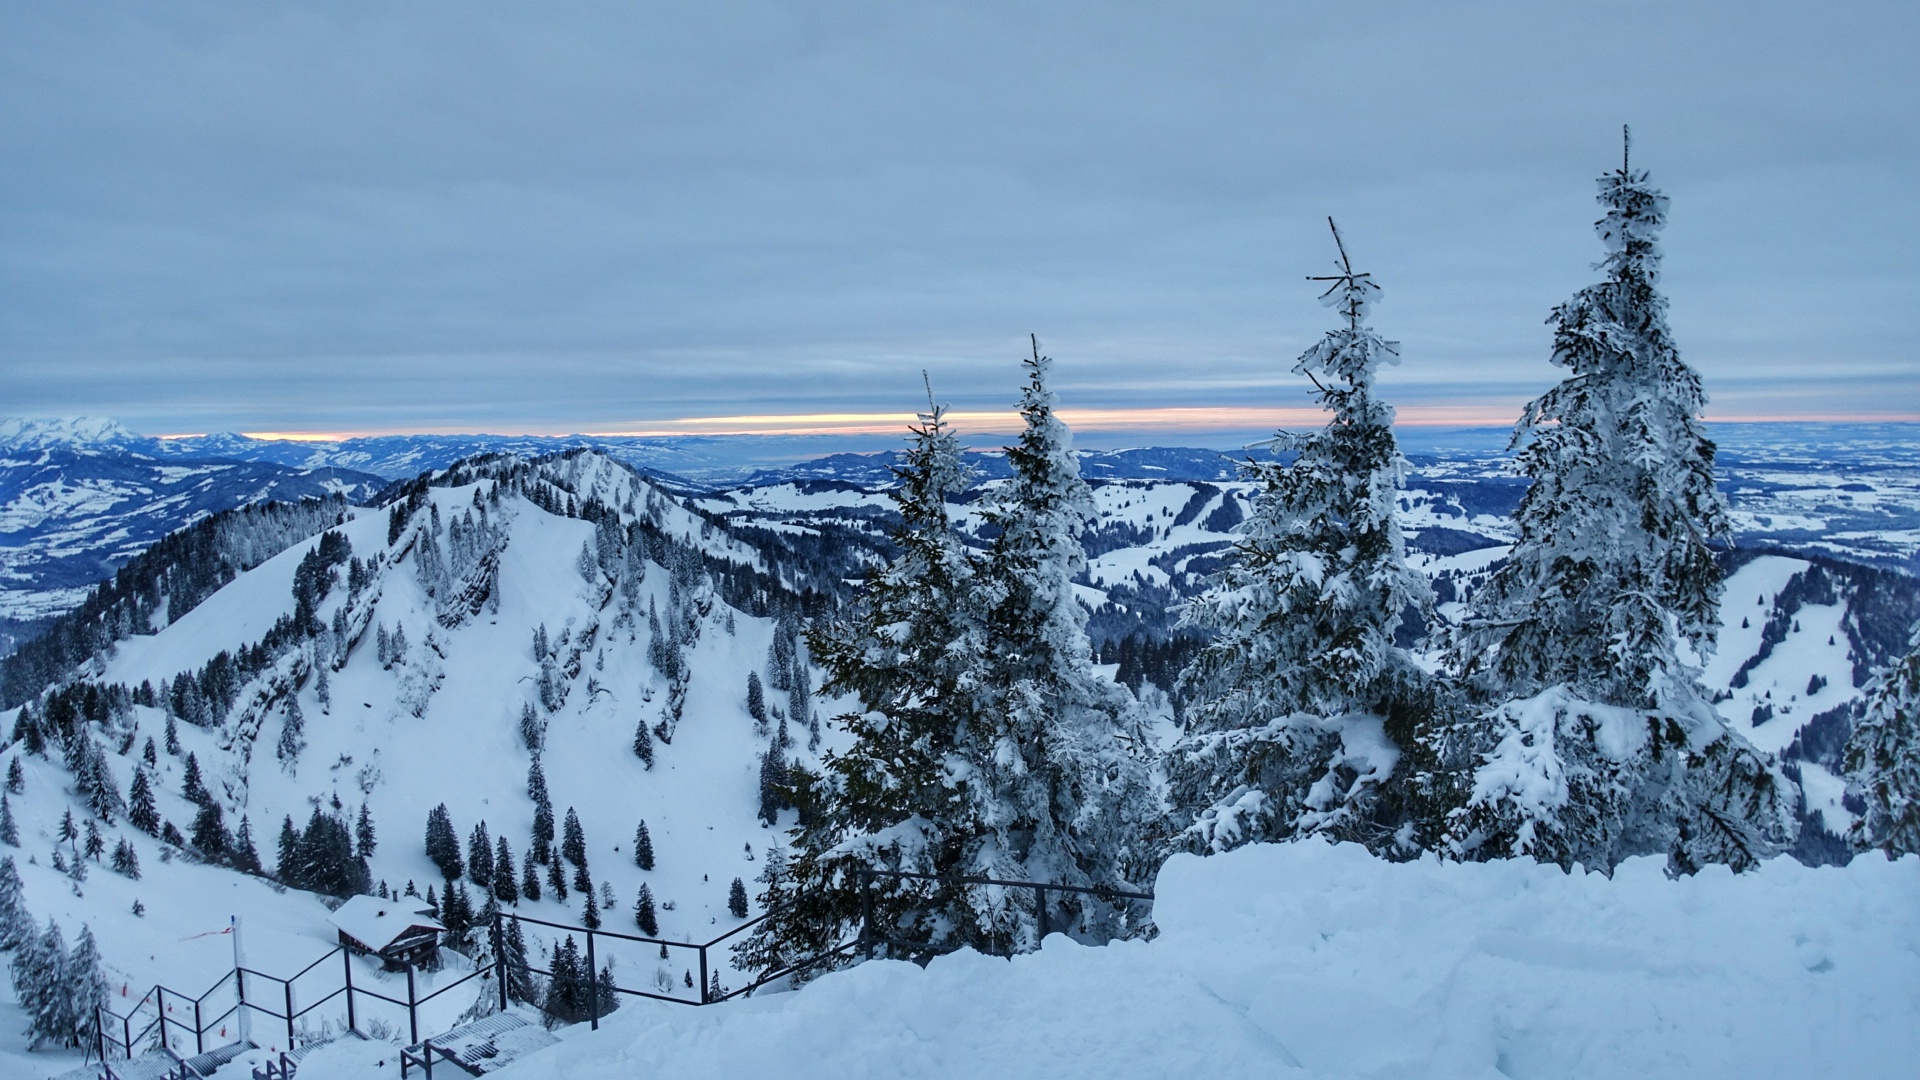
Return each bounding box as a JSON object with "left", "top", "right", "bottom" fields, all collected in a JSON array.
[{"left": 1847, "top": 634, "right": 1920, "bottom": 859}]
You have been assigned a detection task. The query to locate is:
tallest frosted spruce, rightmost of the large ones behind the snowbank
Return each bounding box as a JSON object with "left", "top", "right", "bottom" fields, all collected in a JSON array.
[{"left": 1452, "top": 134, "right": 1793, "bottom": 871}]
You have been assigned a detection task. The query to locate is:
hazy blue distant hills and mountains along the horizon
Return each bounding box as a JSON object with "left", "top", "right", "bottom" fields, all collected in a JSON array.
[{"left": 0, "top": 417, "right": 1920, "bottom": 653}]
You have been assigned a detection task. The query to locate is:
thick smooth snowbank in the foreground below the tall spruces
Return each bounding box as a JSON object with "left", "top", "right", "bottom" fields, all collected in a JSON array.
[{"left": 288, "top": 844, "right": 1920, "bottom": 1080}]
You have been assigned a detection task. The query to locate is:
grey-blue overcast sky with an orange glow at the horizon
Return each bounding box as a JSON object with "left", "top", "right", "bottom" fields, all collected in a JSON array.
[{"left": 0, "top": 0, "right": 1920, "bottom": 442}]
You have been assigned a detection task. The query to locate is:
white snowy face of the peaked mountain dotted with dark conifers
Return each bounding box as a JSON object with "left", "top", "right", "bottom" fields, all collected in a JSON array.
[{"left": 0, "top": 454, "right": 856, "bottom": 1068}]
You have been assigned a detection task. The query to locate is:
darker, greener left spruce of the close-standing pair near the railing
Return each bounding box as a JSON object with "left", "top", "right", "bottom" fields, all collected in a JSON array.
[{"left": 737, "top": 388, "right": 987, "bottom": 970}]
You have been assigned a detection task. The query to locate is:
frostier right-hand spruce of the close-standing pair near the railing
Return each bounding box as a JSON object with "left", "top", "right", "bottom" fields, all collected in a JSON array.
[{"left": 972, "top": 338, "right": 1160, "bottom": 895}]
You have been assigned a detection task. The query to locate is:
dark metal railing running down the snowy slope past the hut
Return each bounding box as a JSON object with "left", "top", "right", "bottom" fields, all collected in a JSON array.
[{"left": 94, "top": 869, "right": 1154, "bottom": 1076}]
